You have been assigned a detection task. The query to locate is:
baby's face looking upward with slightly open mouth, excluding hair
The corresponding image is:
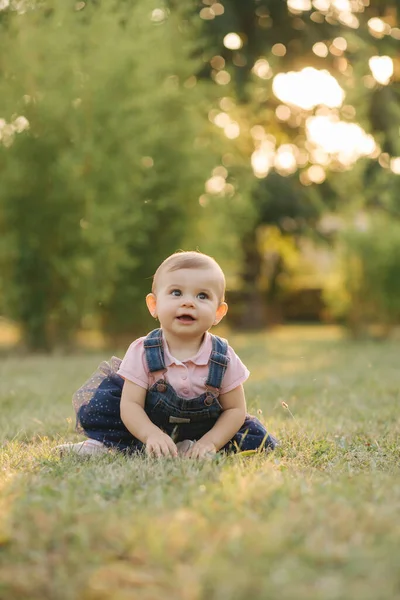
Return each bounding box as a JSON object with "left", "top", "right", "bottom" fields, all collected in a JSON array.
[{"left": 150, "top": 266, "right": 226, "bottom": 337}]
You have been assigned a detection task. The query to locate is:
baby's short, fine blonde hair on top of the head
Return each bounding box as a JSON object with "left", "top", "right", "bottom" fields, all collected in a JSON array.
[{"left": 151, "top": 250, "right": 226, "bottom": 302}]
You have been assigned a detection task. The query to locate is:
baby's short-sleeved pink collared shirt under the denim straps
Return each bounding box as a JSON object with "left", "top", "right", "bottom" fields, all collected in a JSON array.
[{"left": 118, "top": 332, "right": 250, "bottom": 398}]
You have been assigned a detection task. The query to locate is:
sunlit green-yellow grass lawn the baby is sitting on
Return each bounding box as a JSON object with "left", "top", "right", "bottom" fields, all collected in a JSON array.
[{"left": 0, "top": 327, "right": 400, "bottom": 600}]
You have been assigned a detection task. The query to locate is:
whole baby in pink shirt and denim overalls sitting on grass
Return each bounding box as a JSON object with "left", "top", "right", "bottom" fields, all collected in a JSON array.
[{"left": 60, "top": 252, "right": 277, "bottom": 459}]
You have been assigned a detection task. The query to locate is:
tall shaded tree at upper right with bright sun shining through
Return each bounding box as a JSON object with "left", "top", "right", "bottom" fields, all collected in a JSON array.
[{"left": 177, "top": 0, "right": 400, "bottom": 327}]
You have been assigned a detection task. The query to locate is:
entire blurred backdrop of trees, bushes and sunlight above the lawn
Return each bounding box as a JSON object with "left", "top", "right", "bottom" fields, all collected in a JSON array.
[{"left": 0, "top": 0, "right": 400, "bottom": 351}]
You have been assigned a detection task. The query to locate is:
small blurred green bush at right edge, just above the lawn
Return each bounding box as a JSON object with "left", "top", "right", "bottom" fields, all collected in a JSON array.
[{"left": 325, "top": 214, "right": 400, "bottom": 334}]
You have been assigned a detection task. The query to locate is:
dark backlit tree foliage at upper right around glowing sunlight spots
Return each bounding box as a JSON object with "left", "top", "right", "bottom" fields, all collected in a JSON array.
[{"left": 190, "top": 0, "right": 400, "bottom": 325}]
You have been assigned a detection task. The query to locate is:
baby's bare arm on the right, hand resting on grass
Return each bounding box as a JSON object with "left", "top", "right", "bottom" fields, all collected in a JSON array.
[{"left": 187, "top": 385, "right": 246, "bottom": 458}]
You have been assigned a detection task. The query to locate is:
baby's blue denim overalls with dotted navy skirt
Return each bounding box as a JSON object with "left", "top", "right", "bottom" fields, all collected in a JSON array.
[{"left": 77, "top": 329, "right": 277, "bottom": 452}]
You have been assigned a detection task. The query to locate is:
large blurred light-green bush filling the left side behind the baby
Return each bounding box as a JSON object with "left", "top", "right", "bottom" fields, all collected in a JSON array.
[{"left": 0, "top": 0, "right": 213, "bottom": 349}]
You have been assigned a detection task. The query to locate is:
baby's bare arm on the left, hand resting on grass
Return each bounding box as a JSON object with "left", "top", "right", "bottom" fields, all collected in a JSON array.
[{"left": 121, "top": 379, "right": 177, "bottom": 456}]
